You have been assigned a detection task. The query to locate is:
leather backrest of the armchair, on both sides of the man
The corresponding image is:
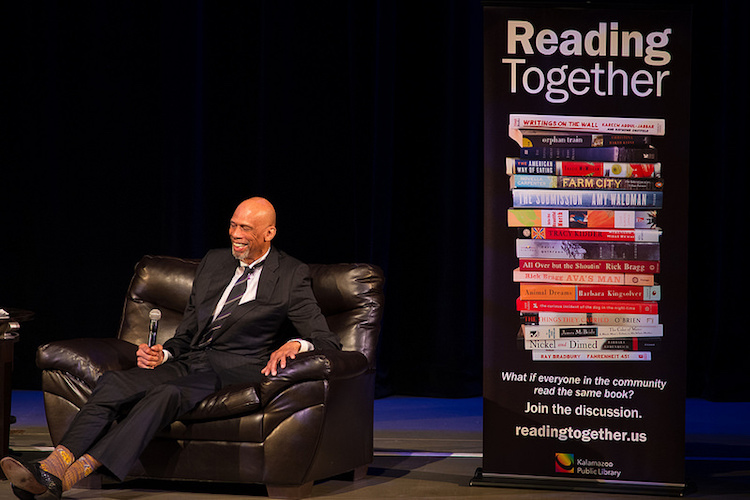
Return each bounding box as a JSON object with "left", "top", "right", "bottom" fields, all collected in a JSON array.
[{"left": 118, "top": 255, "right": 384, "bottom": 369}]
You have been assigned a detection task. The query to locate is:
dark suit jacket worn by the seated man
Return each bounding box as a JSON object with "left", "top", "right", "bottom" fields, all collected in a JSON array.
[{"left": 164, "top": 247, "right": 341, "bottom": 386}]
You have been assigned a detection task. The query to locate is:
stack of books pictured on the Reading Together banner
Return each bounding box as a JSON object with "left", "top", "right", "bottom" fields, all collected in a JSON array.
[{"left": 506, "top": 114, "right": 665, "bottom": 361}]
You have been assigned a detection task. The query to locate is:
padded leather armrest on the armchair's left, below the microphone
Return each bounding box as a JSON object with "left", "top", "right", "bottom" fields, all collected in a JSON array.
[{"left": 36, "top": 338, "right": 138, "bottom": 387}]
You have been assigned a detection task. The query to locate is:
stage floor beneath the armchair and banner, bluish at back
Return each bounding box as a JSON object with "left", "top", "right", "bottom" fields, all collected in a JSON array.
[{"left": 0, "top": 391, "right": 750, "bottom": 500}]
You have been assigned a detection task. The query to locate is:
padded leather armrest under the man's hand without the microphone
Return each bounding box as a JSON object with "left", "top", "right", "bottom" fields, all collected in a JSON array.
[{"left": 260, "top": 350, "right": 368, "bottom": 405}]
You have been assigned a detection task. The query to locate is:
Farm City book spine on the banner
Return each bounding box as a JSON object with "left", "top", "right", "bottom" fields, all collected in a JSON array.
[{"left": 510, "top": 174, "right": 664, "bottom": 191}]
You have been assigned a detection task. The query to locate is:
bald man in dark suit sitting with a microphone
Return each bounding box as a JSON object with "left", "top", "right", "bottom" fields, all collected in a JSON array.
[{"left": 0, "top": 198, "right": 341, "bottom": 498}]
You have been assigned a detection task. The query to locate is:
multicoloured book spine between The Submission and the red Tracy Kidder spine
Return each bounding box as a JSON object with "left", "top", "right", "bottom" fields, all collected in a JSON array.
[{"left": 508, "top": 208, "right": 657, "bottom": 229}]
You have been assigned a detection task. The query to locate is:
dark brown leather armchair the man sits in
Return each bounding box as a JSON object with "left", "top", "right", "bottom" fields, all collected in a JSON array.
[{"left": 36, "top": 256, "right": 384, "bottom": 498}]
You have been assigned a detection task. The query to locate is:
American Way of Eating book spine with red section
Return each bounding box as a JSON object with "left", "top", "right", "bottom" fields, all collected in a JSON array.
[{"left": 505, "top": 158, "right": 661, "bottom": 178}]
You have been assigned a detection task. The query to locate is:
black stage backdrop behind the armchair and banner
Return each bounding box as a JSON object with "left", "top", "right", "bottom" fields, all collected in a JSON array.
[{"left": 0, "top": 0, "right": 750, "bottom": 400}]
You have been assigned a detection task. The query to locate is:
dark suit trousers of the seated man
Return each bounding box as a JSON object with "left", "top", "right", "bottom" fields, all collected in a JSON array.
[{"left": 60, "top": 351, "right": 221, "bottom": 481}]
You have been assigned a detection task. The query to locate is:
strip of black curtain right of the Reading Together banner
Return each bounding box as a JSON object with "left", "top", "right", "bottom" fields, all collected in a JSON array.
[{"left": 687, "top": 0, "right": 750, "bottom": 401}]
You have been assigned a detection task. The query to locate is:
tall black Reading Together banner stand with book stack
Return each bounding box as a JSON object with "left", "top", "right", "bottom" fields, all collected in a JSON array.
[{"left": 472, "top": 2, "right": 691, "bottom": 495}]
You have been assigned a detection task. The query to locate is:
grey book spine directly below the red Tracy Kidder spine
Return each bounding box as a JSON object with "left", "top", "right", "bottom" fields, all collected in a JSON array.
[{"left": 516, "top": 238, "right": 661, "bottom": 261}]
